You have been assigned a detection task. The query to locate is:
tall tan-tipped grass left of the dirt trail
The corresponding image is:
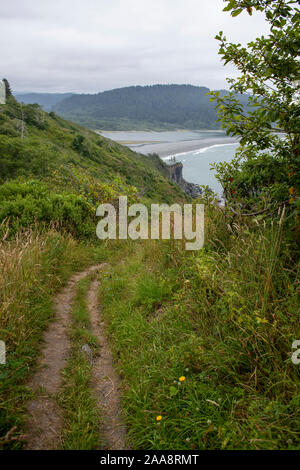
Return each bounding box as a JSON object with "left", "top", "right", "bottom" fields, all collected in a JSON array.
[{"left": 0, "top": 230, "right": 102, "bottom": 448}]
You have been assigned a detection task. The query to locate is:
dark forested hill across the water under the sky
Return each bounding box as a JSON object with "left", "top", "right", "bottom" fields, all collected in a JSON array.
[{"left": 53, "top": 85, "right": 248, "bottom": 130}]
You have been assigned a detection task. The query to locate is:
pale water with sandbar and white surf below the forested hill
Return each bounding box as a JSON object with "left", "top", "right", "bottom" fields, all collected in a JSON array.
[{"left": 101, "top": 130, "right": 238, "bottom": 196}]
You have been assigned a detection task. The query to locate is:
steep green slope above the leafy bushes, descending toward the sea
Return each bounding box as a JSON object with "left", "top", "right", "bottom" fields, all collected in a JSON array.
[{"left": 0, "top": 97, "right": 185, "bottom": 201}]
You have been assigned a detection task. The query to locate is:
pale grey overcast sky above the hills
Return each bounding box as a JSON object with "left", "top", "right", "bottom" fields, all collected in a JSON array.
[{"left": 0, "top": 0, "right": 267, "bottom": 93}]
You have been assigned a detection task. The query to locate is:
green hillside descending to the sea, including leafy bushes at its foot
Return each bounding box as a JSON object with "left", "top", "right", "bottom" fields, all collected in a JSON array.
[{"left": 0, "top": 96, "right": 188, "bottom": 244}]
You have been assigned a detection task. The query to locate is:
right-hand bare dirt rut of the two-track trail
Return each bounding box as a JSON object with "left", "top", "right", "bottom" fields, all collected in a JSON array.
[{"left": 87, "top": 280, "right": 128, "bottom": 450}]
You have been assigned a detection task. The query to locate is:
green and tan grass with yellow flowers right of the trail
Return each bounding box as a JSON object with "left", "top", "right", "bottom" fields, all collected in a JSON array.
[{"left": 101, "top": 207, "right": 300, "bottom": 449}]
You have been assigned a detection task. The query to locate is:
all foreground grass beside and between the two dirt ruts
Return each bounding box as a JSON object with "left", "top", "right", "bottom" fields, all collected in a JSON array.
[{"left": 0, "top": 206, "right": 300, "bottom": 450}]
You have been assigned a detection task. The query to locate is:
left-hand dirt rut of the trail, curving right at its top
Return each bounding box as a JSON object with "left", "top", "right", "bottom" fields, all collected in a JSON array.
[{"left": 26, "top": 264, "right": 103, "bottom": 450}]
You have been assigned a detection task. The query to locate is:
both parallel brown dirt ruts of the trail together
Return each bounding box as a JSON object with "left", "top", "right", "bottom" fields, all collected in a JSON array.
[{"left": 25, "top": 264, "right": 126, "bottom": 450}]
